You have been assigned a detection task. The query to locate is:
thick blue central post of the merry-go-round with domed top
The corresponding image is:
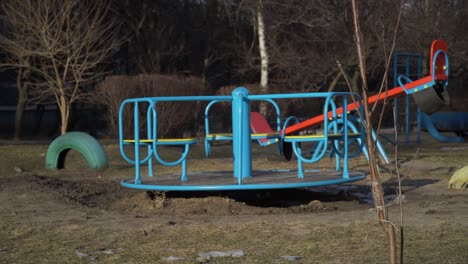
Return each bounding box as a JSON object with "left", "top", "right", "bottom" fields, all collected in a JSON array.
[{"left": 232, "top": 87, "right": 252, "bottom": 184}]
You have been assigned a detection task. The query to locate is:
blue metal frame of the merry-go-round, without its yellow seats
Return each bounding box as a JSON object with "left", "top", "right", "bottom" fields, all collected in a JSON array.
[{"left": 119, "top": 87, "right": 365, "bottom": 191}]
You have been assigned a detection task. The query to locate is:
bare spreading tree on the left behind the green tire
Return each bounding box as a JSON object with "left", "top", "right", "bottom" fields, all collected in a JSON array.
[{"left": 2, "top": 0, "right": 121, "bottom": 134}]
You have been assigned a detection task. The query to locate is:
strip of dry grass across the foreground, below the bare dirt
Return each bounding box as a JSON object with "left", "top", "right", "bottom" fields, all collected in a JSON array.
[{"left": 0, "top": 218, "right": 468, "bottom": 263}]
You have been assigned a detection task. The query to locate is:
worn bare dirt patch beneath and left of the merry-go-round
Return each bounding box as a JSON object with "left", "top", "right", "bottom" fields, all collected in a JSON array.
[{"left": 24, "top": 174, "right": 358, "bottom": 217}]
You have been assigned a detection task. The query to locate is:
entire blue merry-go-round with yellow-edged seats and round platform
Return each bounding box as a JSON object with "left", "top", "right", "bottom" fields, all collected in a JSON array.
[{"left": 119, "top": 87, "right": 365, "bottom": 191}]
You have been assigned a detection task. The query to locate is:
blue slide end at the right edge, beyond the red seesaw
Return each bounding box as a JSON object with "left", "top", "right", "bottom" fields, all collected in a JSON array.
[{"left": 421, "top": 112, "right": 468, "bottom": 142}]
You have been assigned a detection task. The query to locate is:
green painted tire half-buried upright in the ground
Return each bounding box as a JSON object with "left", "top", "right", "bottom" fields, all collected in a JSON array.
[{"left": 46, "top": 132, "right": 108, "bottom": 171}]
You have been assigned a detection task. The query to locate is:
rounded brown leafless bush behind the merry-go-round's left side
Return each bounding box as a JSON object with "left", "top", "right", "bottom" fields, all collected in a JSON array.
[{"left": 95, "top": 74, "right": 205, "bottom": 138}]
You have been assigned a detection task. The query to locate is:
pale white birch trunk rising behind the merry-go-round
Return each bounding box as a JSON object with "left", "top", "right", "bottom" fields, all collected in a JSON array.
[{"left": 257, "top": 0, "right": 269, "bottom": 115}]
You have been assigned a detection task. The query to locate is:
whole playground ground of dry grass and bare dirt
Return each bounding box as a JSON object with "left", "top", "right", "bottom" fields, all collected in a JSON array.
[{"left": 0, "top": 134, "right": 468, "bottom": 263}]
